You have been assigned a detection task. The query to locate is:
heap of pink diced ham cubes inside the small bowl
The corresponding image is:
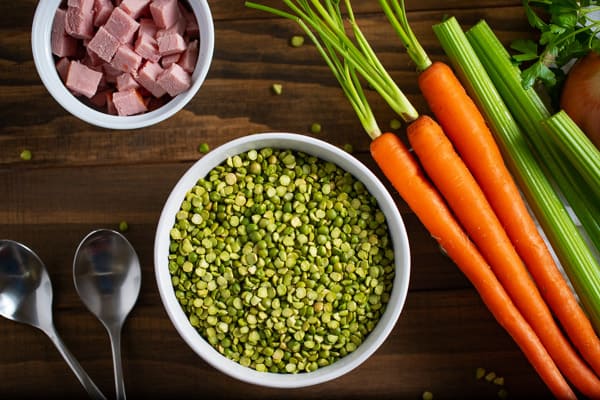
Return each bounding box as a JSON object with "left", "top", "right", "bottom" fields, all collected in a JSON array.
[{"left": 51, "top": 0, "right": 199, "bottom": 115}]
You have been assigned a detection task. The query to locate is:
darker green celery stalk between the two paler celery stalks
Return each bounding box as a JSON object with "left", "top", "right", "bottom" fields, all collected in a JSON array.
[{"left": 466, "top": 21, "right": 600, "bottom": 247}]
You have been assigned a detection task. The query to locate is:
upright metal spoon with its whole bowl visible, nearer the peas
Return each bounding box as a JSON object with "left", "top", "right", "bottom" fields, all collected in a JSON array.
[{"left": 73, "top": 229, "right": 142, "bottom": 399}]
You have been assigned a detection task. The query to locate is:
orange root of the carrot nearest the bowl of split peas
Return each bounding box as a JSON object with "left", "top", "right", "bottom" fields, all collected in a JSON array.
[{"left": 371, "top": 130, "right": 576, "bottom": 399}]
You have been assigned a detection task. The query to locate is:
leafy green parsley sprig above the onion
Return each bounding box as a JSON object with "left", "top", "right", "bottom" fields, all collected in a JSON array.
[{"left": 511, "top": 0, "right": 600, "bottom": 91}]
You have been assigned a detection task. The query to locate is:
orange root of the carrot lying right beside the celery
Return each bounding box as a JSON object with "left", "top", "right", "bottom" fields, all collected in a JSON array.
[{"left": 419, "top": 62, "right": 600, "bottom": 375}]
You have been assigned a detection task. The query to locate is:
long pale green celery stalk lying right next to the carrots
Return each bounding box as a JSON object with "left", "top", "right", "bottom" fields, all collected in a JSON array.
[{"left": 433, "top": 17, "right": 600, "bottom": 332}]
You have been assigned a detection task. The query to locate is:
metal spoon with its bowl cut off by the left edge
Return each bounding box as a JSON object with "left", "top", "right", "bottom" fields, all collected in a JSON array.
[{"left": 0, "top": 240, "right": 106, "bottom": 399}]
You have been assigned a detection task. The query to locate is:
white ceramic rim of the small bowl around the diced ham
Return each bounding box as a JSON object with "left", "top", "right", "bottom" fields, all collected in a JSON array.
[{"left": 31, "top": 0, "right": 214, "bottom": 129}]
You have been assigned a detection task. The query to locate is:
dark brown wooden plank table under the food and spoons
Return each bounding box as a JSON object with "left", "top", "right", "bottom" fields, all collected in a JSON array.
[{"left": 0, "top": 0, "right": 549, "bottom": 399}]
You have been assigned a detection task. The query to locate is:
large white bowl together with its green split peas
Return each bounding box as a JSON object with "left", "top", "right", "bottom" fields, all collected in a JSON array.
[{"left": 154, "top": 133, "right": 410, "bottom": 388}]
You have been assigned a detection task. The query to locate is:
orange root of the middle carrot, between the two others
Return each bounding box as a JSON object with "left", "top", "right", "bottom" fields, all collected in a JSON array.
[{"left": 407, "top": 117, "right": 600, "bottom": 398}]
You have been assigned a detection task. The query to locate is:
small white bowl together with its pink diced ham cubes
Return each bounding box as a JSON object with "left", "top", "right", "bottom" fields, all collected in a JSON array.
[{"left": 31, "top": 0, "right": 214, "bottom": 129}]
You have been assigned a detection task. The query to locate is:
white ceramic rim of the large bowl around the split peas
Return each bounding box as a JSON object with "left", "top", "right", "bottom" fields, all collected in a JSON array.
[{"left": 154, "top": 133, "right": 410, "bottom": 388}]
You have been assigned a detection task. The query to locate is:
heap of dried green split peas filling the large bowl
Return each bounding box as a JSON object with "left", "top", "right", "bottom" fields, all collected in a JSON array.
[{"left": 169, "top": 148, "right": 394, "bottom": 373}]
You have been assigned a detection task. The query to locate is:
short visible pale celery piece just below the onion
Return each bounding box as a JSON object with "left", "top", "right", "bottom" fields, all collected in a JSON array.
[{"left": 542, "top": 110, "right": 600, "bottom": 202}]
